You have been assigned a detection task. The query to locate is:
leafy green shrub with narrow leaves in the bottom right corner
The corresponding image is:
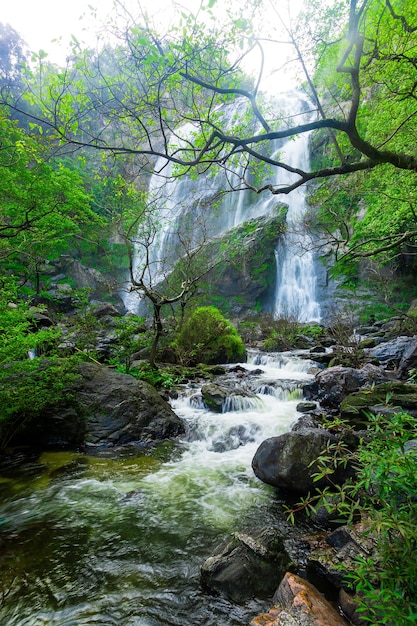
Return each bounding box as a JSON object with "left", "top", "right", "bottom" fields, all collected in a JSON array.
[{"left": 349, "top": 414, "right": 417, "bottom": 625}]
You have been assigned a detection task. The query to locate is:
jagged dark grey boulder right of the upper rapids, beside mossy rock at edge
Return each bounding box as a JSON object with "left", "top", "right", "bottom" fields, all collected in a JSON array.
[{"left": 303, "top": 363, "right": 389, "bottom": 409}]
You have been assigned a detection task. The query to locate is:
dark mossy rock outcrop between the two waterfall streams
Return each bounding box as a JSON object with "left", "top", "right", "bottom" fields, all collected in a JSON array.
[{"left": 198, "top": 211, "right": 286, "bottom": 317}]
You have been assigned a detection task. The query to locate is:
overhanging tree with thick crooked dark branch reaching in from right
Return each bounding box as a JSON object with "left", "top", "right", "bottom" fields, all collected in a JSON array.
[{"left": 2, "top": 0, "right": 417, "bottom": 183}]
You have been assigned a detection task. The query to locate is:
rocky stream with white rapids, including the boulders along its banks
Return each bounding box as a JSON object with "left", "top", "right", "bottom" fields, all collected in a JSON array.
[{"left": 0, "top": 314, "right": 417, "bottom": 626}]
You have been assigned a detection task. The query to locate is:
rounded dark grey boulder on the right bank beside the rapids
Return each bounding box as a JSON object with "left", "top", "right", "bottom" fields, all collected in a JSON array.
[{"left": 252, "top": 428, "right": 351, "bottom": 494}]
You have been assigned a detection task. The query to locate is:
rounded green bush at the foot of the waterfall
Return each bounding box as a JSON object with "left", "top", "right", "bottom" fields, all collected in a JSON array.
[{"left": 174, "top": 306, "right": 246, "bottom": 364}]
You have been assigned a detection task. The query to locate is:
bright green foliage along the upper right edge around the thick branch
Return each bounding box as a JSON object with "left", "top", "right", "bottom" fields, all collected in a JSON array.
[{"left": 304, "top": 0, "right": 417, "bottom": 279}]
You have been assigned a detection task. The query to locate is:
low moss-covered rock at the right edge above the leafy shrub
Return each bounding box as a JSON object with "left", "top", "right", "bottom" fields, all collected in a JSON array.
[{"left": 340, "top": 381, "right": 417, "bottom": 426}]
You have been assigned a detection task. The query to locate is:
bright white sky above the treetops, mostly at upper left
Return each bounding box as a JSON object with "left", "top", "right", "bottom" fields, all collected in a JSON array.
[{"left": 0, "top": 0, "right": 299, "bottom": 91}]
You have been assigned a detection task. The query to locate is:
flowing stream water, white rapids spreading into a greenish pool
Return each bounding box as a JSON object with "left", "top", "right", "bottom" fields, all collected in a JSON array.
[{"left": 0, "top": 353, "right": 312, "bottom": 626}]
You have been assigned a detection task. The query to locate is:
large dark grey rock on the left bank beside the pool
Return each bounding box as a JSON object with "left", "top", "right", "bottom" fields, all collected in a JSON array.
[{"left": 14, "top": 363, "right": 184, "bottom": 448}]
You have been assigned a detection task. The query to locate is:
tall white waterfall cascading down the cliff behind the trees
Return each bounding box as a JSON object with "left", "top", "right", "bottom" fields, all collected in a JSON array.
[{"left": 124, "top": 94, "right": 321, "bottom": 322}]
